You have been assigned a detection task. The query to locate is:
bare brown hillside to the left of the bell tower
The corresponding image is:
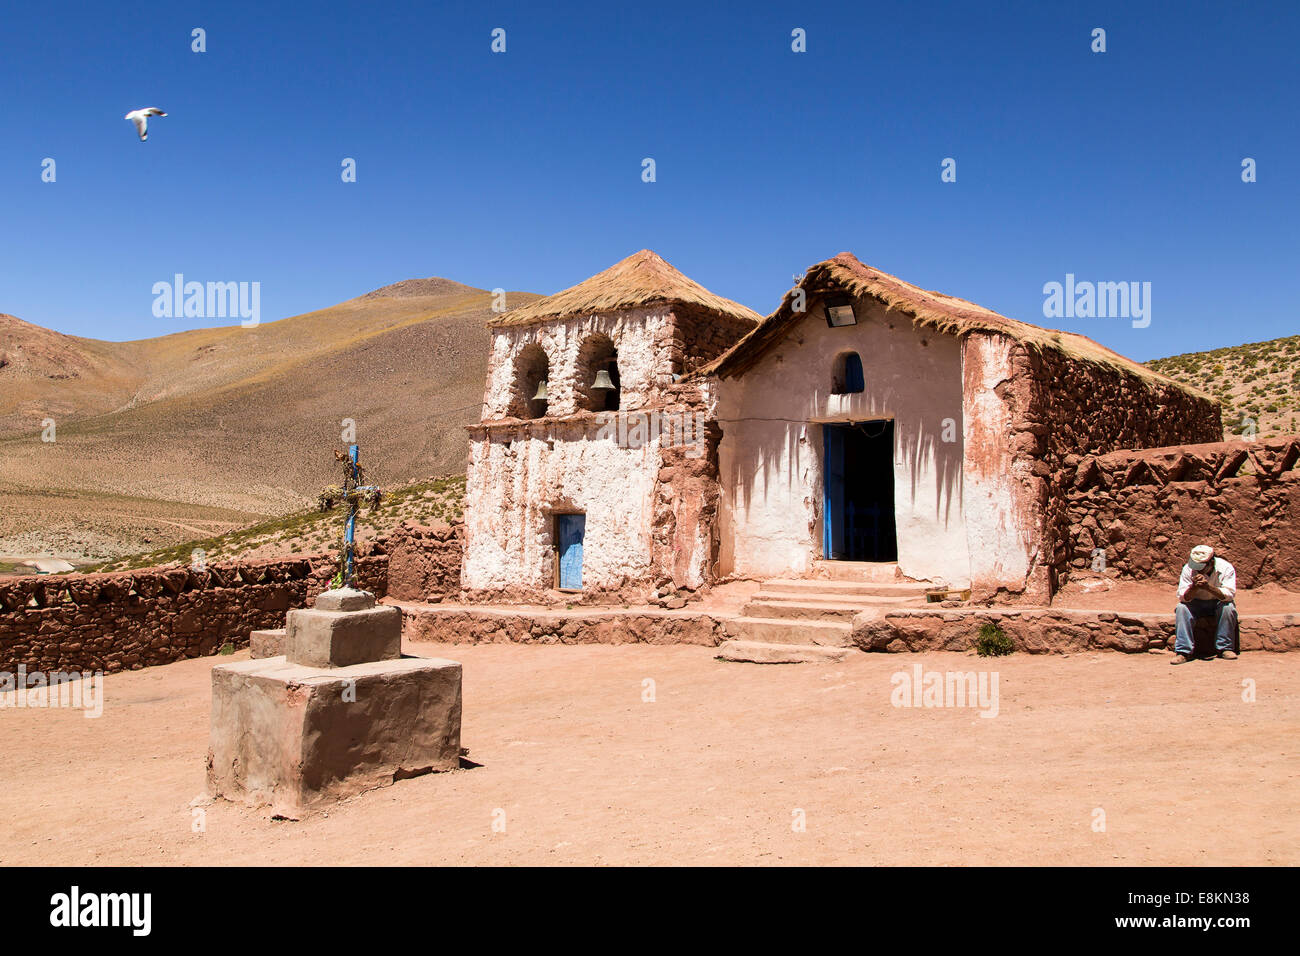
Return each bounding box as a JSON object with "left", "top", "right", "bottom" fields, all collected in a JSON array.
[{"left": 0, "top": 278, "right": 536, "bottom": 561}]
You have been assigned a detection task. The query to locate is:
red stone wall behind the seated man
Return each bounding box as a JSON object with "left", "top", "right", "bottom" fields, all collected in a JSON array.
[{"left": 1056, "top": 438, "right": 1300, "bottom": 589}]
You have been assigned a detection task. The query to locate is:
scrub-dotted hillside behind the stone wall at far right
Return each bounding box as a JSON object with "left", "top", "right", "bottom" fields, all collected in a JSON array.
[{"left": 1147, "top": 336, "right": 1300, "bottom": 438}]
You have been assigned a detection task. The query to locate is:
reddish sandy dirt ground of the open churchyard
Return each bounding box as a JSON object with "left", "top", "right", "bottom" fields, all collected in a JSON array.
[{"left": 0, "top": 644, "right": 1300, "bottom": 865}]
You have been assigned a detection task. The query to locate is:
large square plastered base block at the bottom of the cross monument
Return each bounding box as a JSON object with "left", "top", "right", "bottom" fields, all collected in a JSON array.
[{"left": 208, "top": 655, "right": 460, "bottom": 819}]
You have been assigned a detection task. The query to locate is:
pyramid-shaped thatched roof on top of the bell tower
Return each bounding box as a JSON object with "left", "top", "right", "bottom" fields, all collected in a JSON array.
[{"left": 488, "top": 248, "right": 762, "bottom": 328}]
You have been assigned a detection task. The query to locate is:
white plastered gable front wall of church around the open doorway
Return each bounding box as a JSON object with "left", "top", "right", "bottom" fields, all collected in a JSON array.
[{"left": 714, "top": 298, "right": 970, "bottom": 585}]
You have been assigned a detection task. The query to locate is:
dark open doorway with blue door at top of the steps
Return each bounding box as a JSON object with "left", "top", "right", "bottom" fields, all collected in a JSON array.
[{"left": 822, "top": 419, "right": 898, "bottom": 561}]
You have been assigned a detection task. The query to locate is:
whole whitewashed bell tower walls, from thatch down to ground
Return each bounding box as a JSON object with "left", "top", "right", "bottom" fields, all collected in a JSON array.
[{"left": 462, "top": 306, "right": 750, "bottom": 601}]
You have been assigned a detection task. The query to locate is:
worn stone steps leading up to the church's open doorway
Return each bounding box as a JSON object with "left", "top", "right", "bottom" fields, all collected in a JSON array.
[{"left": 718, "top": 561, "right": 930, "bottom": 663}]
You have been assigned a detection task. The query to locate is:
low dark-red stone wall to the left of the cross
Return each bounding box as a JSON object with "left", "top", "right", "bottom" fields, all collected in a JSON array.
[{"left": 0, "top": 544, "right": 389, "bottom": 674}]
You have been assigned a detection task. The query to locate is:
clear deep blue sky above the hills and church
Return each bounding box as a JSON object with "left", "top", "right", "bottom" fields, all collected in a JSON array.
[{"left": 0, "top": 0, "right": 1300, "bottom": 359}]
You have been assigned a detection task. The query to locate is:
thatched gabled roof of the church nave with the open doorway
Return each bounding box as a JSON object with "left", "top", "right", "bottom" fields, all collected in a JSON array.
[{"left": 697, "top": 252, "right": 1209, "bottom": 398}]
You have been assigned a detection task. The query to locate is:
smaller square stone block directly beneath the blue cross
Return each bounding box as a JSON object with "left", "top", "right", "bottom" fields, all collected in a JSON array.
[{"left": 285, "top": 607, "right": 402, "bottom": 667}]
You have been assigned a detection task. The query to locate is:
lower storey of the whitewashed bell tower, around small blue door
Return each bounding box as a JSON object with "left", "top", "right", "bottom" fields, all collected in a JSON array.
[{"left": 462, "top": 385, "right": 718, "bottom": 602}]
